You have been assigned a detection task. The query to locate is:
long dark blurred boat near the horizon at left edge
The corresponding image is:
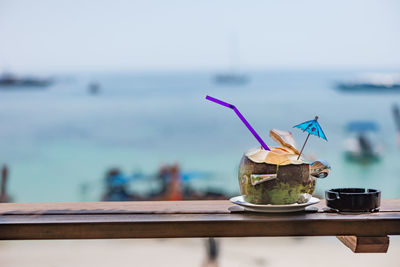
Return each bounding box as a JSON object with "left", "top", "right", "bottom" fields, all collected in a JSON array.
[{"left": 0, "top": 73, "right": 53, "bottom": 89}]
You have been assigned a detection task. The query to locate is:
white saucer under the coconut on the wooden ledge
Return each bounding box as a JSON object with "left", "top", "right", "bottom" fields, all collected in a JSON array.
[{"left": 229, "top": 196, "right": 320, "bottom": 213}]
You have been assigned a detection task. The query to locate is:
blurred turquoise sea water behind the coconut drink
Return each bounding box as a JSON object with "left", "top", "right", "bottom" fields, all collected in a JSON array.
[{"left": 0, "top": 71, "right": 400, "bottom": 202}]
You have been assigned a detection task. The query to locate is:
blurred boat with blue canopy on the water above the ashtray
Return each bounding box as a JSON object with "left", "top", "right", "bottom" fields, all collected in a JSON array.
[{"left": 345, "top": 121, "right": 383, "bottom": 164}]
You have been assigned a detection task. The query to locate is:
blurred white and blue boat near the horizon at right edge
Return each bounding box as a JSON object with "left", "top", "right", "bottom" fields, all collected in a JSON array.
[{"left": 336, "top": 74, "right": 400, "bottom": 92}]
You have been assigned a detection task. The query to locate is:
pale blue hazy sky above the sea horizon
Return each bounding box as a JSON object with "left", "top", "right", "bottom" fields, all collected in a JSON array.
[{"left": 0, "top": 0, "right": 400, "bottom": 72}]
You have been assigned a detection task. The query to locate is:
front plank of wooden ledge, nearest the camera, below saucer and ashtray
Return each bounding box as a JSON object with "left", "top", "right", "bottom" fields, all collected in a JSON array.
[{"left": 0, "top": 213, "right": 400, "bottom": 239}]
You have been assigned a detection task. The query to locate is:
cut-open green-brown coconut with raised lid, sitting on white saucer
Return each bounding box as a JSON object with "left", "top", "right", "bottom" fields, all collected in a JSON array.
[{"left": 238, "top": 129, "right": 330, "bottom": 205}]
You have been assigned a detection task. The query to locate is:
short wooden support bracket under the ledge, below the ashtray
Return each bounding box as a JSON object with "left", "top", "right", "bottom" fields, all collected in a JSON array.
[{"left": 336, "top": 235, "right": 389, "bottom": 253}]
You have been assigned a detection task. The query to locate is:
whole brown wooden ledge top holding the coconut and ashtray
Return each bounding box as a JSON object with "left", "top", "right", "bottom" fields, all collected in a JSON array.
[{"left": 0, "top": 199, "right": 400, "bottom": 240}]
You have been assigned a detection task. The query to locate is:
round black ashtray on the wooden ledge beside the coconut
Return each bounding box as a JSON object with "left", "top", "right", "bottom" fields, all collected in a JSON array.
[{"left": 325, "top": 188, "right": 381, "bottom": 212}]
